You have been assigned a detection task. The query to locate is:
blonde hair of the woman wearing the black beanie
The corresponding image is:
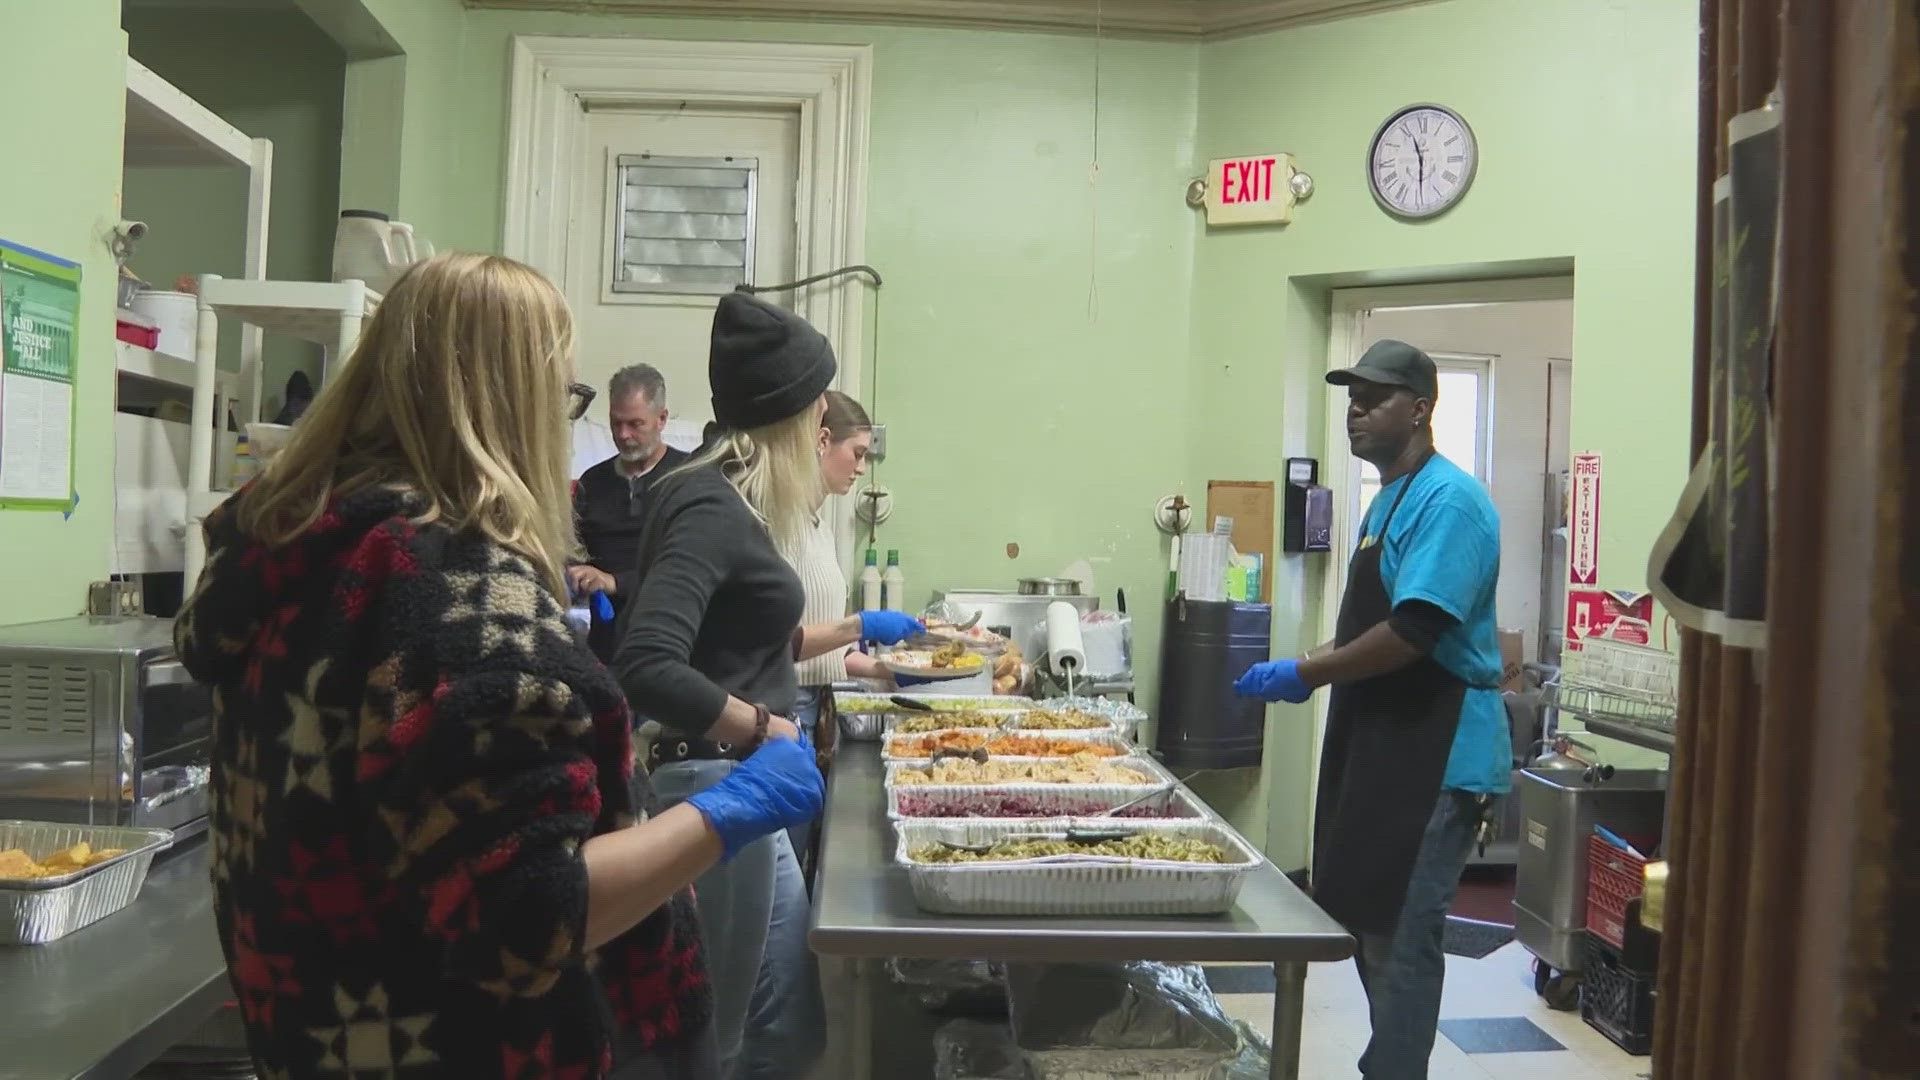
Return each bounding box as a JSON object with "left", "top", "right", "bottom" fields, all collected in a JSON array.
[{"left": 676, "top": 404, "right": 826, "bottom": 553}]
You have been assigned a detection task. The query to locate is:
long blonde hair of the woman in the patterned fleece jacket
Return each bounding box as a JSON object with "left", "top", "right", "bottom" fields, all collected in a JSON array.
[{"left": 238, "top": 254, "right": 576, "bottom": 596}]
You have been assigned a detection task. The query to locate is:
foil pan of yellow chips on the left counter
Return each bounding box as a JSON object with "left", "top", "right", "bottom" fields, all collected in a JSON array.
[{"left": 0, "top": 821, "right": 173, "bottom": 945}]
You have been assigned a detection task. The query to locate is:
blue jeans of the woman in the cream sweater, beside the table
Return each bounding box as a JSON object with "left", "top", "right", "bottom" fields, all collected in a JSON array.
[{"left": 735, "top": 818, "right": 828, "bottom": 1080}]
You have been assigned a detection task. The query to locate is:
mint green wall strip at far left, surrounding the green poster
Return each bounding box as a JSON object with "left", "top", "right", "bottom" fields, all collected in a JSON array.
[{"left": 0, "top": 0, "right": 127, "bottom": 623}]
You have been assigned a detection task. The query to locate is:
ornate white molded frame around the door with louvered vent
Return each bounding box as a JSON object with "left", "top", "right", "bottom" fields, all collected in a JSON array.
[{"left": 501, "top": 35, "right": 874, "bottom": 553}]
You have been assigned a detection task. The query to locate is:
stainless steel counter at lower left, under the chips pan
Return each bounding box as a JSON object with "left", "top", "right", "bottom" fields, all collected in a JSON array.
[{"left": 0, "top": 840, "right": 228, "bottom": 1080}]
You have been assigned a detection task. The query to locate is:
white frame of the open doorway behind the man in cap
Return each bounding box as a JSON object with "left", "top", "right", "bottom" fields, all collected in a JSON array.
[{"left": 1306, "top": 277, "right": 1574, "bottom": 814}]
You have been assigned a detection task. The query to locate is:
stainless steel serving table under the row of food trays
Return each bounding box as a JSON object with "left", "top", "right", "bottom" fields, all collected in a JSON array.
[{"left": 808, "top": 744, "right": 1354, "bottom": 1080}]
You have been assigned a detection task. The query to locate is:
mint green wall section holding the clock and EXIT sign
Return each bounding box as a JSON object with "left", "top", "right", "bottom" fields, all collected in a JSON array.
[{"left": 1185, "top": 0, "right": 1697, "bottom": 865}]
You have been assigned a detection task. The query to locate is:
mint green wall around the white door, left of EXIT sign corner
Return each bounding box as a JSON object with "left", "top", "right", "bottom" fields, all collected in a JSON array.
[{"left": 334, "top": 4, "right": 1198, "bottom": 714}]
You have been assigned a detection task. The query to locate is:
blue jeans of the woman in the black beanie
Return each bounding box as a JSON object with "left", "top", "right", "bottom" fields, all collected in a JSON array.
[{"left": 653, "top": 761, "right": 775, "bottom": 1076}]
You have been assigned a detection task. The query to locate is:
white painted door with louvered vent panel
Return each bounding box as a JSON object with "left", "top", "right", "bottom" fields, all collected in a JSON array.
[{"left": 564, "top": 108, "right": 801, "bottom": 430}]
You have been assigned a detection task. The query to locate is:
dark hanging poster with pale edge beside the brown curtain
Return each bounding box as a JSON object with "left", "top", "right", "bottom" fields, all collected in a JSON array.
[{"left": 1647, "top": 104, "right": 1782, "bottom": 648}]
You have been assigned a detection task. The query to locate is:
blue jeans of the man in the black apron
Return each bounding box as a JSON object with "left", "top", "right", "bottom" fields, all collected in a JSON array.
[{"left": 1354, "top": 790, "right": 1498, "bottom": 1080}]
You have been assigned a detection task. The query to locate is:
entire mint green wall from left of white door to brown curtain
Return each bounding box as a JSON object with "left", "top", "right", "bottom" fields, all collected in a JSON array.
[{"left": 330, "top": 0, "right": 1697, "bottom": 865}]
